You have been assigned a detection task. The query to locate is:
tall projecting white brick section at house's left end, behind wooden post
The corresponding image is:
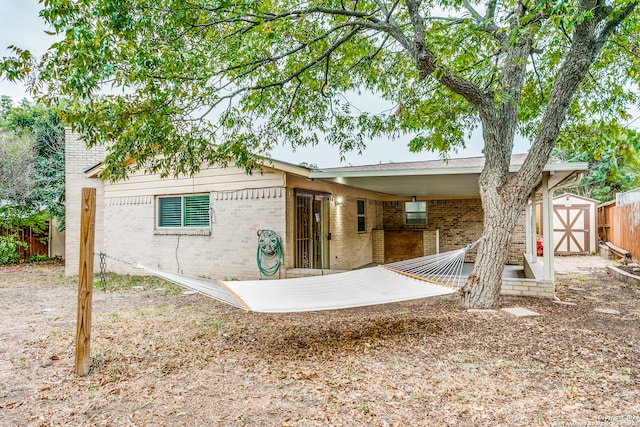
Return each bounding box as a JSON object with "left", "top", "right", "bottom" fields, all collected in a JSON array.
[{"left": 64, "top": 129, "right": 104, "bottom": 275}]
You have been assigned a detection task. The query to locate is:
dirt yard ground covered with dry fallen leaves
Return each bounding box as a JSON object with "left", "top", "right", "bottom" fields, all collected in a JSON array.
[{"left": 0, "top": 264, "right": 640, "bottom": 426}]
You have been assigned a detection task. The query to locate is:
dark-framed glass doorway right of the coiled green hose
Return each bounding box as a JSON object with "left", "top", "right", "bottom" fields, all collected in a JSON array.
[{"left": 295, "top": 190, "right": 330, "bottom": 269}]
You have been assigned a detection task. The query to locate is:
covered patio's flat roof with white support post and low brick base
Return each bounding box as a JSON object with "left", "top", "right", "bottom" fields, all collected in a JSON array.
[{"left": 309, "top": 154, "right": 588, "bottom": 298}]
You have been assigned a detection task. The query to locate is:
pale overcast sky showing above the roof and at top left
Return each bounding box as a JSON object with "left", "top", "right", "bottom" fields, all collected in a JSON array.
[{"left": 0, "top": 0, "right": 529, "bottom": 168}]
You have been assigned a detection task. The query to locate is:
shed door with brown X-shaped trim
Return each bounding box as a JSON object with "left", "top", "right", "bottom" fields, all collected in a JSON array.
[{"left": 553, "top": 205, "right": 591, "bottom": 255}]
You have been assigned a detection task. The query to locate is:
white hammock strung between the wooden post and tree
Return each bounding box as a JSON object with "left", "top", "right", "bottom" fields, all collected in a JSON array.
[{"left": 135, "top": 242, "right": 477, "bottom": 313}]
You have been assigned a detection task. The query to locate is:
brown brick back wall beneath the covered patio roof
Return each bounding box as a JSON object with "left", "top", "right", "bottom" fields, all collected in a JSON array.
[{"left": 383, "top": 198, "right": 526, "bottom": 264}]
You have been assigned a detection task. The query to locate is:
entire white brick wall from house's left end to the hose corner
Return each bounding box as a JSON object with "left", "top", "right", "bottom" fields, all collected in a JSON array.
[{"left": 65, "top": 130, "right": 286, "bottom": 279}]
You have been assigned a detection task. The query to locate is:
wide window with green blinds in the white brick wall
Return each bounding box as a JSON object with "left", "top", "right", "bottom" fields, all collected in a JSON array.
[{"left": 158, "top": 194, "right": 210, "bottom": 228}]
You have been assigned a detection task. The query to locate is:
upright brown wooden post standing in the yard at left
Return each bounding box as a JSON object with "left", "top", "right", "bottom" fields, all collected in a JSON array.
[{"left": 76, "top": 188, "right": 96, "bottom": 376}]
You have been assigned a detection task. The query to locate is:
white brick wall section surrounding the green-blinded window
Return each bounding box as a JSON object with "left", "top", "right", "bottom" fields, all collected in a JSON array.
[{"left": 105, "top": 188, "right": 285, "bottom": 279}]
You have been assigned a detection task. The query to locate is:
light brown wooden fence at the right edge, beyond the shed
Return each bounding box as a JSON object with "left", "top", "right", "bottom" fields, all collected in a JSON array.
[{"left": 607, "top": 202, "right": 640, "bottom": 261}]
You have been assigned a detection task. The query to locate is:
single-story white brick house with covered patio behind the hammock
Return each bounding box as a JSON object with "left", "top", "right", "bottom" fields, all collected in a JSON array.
[{"left": 66, "top": 131, "right": 586, "bottom": 297}]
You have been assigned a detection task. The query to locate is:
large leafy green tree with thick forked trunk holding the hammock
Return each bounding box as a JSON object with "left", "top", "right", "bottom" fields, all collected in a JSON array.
[{"left": 1, "top": 0, "right": 640, "bottom": 307}]
